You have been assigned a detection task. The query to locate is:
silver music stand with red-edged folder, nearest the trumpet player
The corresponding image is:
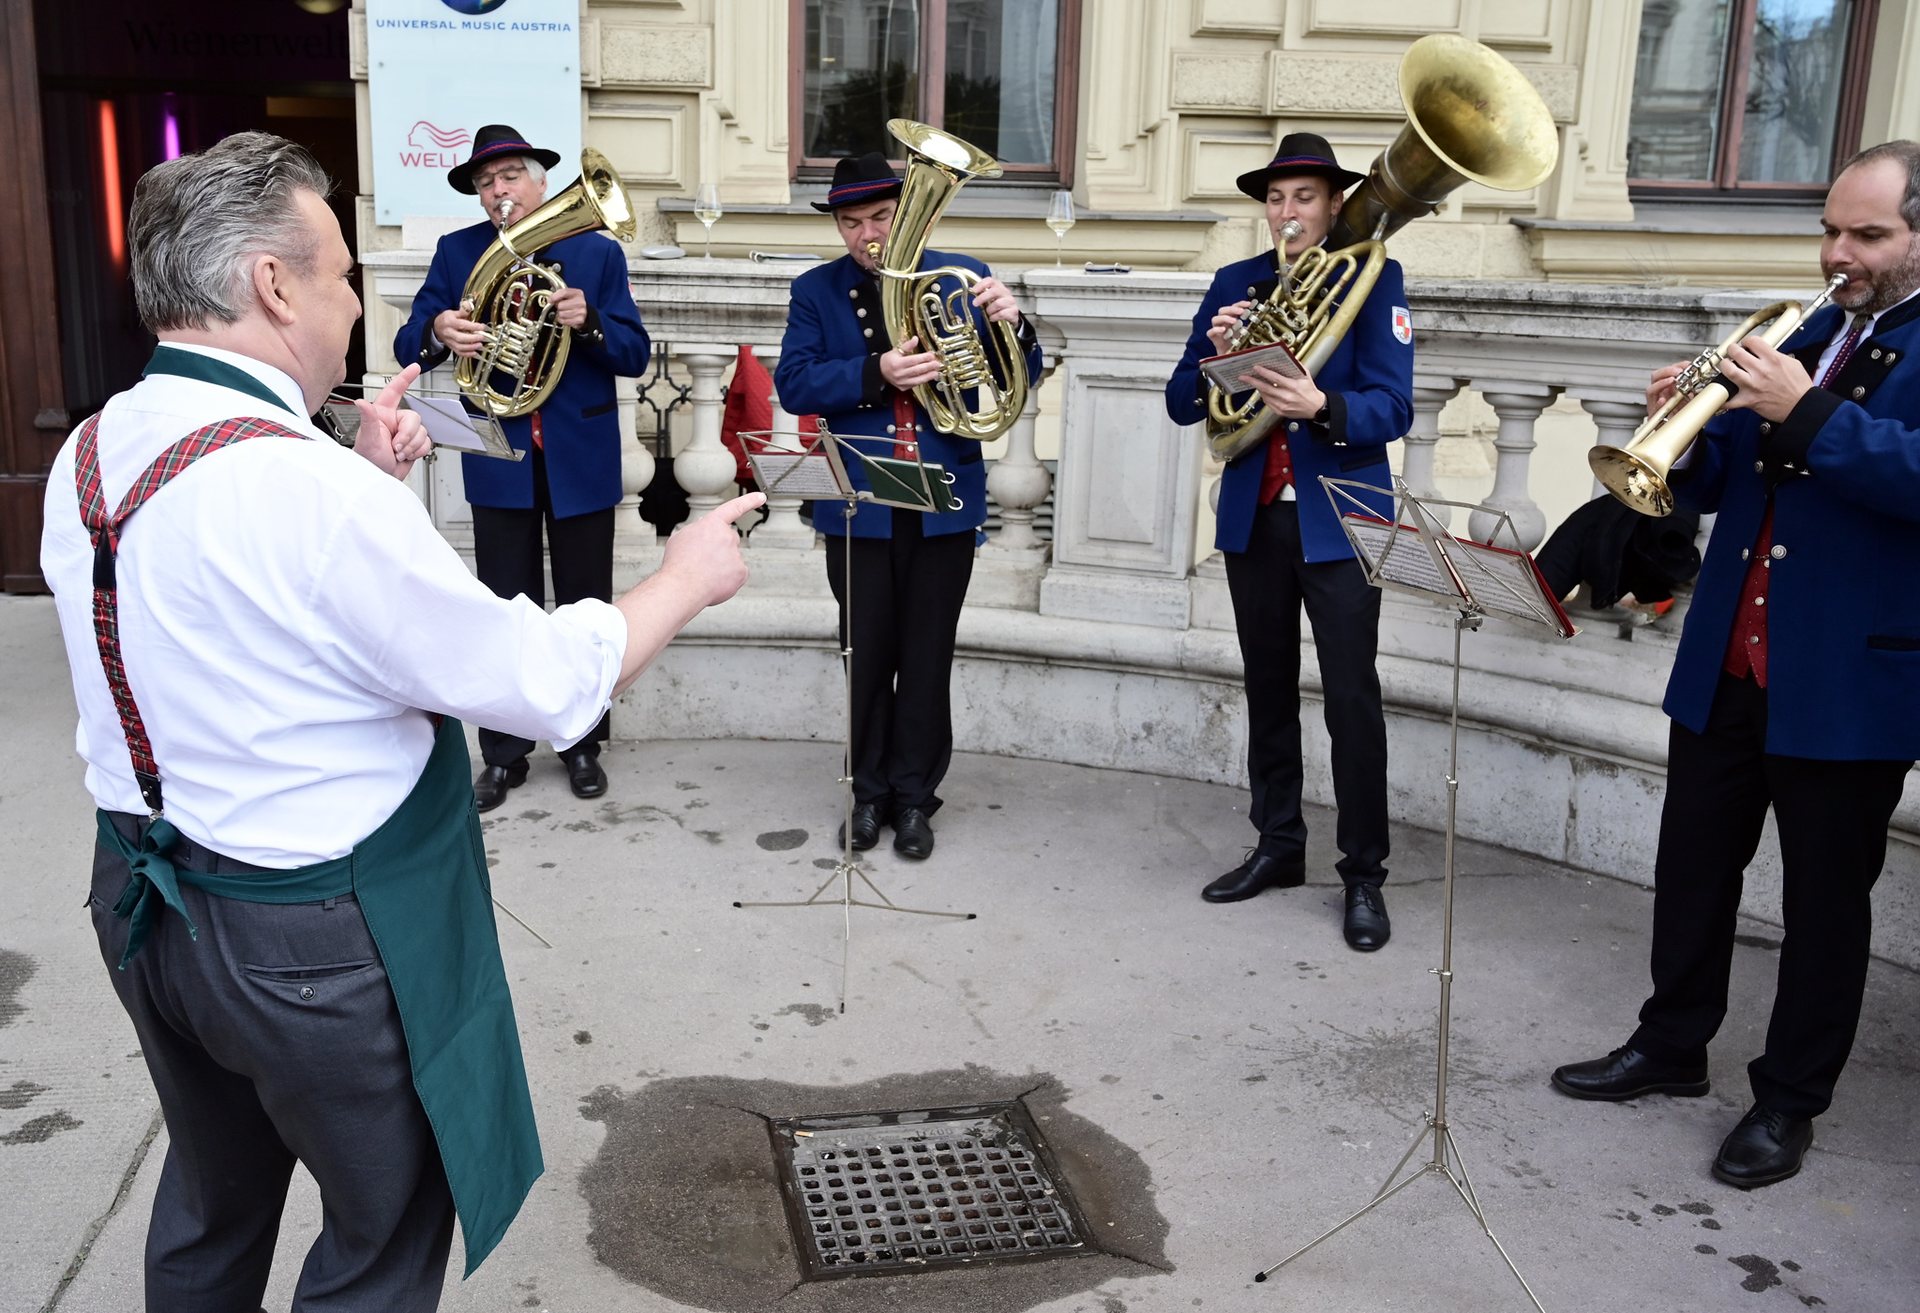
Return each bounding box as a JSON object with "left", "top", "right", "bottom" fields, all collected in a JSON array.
[{"left": 1254, "top": 476, "right": 1578, "bottom": 1313}]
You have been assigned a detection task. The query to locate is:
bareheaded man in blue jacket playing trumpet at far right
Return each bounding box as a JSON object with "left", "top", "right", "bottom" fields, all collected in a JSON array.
[{"left": 1553, "top": 142, "right": 1920, "bottom": 1188}]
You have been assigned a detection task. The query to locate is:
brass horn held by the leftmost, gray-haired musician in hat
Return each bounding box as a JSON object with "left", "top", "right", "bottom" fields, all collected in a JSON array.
[{"left": 453, "top": 148, "right": 637, "bottom": 418}]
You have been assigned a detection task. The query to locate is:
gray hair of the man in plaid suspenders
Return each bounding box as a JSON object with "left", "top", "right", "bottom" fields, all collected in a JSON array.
[{"left": 127, "top": 132, "right": 334, "bottom": 332}]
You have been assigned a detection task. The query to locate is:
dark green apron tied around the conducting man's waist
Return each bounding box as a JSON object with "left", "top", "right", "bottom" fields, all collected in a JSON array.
[{"left": 100, "top": 720, "right": 541, "bottom": 1277}]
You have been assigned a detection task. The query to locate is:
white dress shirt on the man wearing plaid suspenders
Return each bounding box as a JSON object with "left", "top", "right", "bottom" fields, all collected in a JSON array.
[{"left": 40, "top": 344, "right": 626, "bottom": 868}]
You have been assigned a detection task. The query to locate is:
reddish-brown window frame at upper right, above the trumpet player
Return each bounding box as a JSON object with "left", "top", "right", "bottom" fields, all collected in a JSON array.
[{"left": 1626, "top": 0, "right": 1880, "bottom": 202}]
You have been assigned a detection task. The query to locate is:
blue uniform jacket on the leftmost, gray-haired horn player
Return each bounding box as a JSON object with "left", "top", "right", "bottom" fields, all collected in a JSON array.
[{"left": 394, "top": 219, "right": 653, "bottom": 516}]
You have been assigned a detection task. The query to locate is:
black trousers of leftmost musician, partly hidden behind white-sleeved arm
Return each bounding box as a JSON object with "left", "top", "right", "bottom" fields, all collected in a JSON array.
[{"left": 472, "top": 449, "right": 614, "bottom": 766}]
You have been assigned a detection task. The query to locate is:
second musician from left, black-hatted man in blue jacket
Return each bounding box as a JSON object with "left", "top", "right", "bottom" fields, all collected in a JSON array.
[{"left": 774, "top": 152, "right": 1041, "bottom": 860}]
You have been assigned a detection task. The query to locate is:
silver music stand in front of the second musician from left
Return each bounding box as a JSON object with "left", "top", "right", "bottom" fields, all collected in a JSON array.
[{"left": 733, "top": 422, "right": 977, "bottom": 1012}]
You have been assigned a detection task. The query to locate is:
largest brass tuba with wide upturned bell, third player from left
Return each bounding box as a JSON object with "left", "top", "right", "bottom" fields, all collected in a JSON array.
[{"left": 1206, "top": 33, "right": 1559, "bottom": 461}]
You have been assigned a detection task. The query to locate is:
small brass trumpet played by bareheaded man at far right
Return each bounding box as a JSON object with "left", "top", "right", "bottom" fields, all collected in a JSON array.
[{"left": 1586, "top": 275, "right": 1847, "bottom": 516}]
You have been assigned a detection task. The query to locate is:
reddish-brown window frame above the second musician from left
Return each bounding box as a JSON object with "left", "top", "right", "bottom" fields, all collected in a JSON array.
[{"left": 787, "top": 0, "right": 1081, "bottom": 188}]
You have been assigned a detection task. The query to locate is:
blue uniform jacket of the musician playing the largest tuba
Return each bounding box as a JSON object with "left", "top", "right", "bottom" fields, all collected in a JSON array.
[{"left": 1167, "top": 251, "right": 1413, "bottom": 561}]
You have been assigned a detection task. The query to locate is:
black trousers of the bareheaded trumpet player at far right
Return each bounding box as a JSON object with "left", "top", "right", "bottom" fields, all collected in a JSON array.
[{"left": 1632, "top": 676, "right": 1912, "bottom": 1117}]
